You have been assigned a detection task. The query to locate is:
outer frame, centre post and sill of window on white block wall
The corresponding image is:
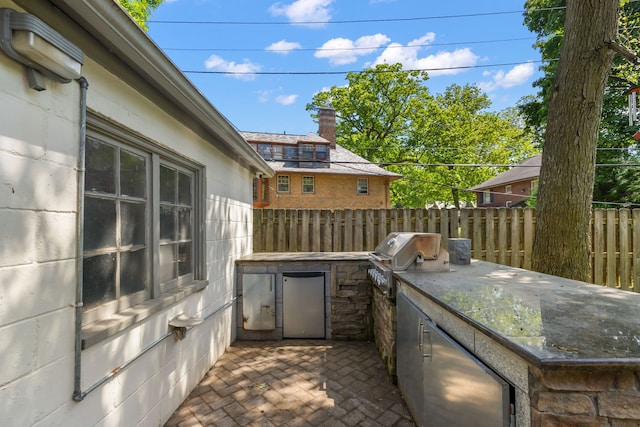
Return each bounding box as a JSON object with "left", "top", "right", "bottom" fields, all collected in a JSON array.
[{"left": 79, "top": 113, "right": 208, "bottom": 349}]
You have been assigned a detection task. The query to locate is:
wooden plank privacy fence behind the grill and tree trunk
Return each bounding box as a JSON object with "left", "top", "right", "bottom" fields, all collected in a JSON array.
[{"left": 253, "top": 208, "right": 640, "bottom": 291}]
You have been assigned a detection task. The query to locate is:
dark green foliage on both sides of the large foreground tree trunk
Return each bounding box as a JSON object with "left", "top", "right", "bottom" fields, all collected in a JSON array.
[{"left": 518, "top": 0, "right": 640, "bottom": 206}]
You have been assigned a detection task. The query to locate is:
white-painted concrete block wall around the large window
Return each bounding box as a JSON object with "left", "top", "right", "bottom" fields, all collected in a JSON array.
[{"left": 0, "top": 0, "right": 253, "bottom": 426}]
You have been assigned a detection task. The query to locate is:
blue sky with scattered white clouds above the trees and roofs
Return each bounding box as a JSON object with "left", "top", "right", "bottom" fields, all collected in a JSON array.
[{"left": 148, "top": 0, "right": 540, "bottom": 134}]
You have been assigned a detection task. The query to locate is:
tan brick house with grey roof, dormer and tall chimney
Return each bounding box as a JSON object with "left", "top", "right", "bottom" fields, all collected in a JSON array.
[{"left": 240, "top": 109, "right": 401, "bottom": 209}]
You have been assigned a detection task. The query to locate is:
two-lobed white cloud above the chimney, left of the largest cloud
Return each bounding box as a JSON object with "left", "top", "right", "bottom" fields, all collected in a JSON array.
[{"left": 313, "top": 33, "right": 391, "bottom": 65}]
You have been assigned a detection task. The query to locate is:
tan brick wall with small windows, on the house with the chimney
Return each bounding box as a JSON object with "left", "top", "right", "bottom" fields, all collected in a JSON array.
[{"left": 261, "top": 172, "right": 389, "bottom": 209}]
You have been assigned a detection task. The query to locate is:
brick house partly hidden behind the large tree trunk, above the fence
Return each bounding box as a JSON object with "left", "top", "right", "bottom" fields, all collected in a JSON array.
[{"left": 470, "top": 154, "right": 542, "bottom": 208}]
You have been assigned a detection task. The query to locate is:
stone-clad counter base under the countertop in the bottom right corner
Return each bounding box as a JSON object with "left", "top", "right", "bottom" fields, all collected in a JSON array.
[{"left": 529, "top": 368, "right": 640, "bottom": 427}]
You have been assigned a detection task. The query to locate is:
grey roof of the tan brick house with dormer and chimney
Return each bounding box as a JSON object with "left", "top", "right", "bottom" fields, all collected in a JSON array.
[{"left": 240, "top": 132, "right": 402, "bottom": 179}]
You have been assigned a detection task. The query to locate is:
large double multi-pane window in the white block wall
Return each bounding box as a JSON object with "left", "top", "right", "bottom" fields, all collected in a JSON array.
[{"left": 82, "top": 120, "right": 206, "bottom": 332}]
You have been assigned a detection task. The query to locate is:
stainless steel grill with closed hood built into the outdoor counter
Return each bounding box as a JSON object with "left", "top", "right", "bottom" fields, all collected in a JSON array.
[{"left": 368, "top": 232, "right": 449, "bottom": 298}]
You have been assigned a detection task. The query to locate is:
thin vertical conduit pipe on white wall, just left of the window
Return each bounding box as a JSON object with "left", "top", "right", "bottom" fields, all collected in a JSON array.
[{"left": 73, "top": 77, "right": 89, "bottom": 401}]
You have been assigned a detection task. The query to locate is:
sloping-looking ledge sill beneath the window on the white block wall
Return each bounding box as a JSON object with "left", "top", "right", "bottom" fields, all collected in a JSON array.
[{"left": 82, "top": 280, "right": 209, "bottom": 350}]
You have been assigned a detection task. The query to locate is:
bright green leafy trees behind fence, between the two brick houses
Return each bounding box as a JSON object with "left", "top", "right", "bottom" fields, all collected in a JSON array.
[{"left": 307, "top": 64, "right": 536, "bottom": 207}]
